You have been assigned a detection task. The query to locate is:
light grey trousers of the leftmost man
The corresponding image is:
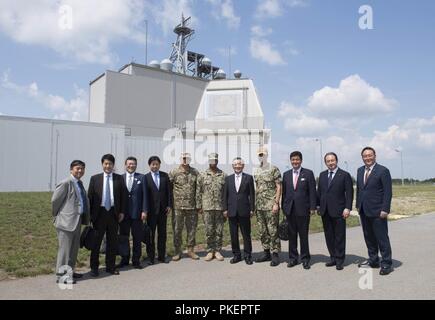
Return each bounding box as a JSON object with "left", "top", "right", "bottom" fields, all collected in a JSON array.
[{"left": 56, "top": 217, "right": 82, "bottom": 276}]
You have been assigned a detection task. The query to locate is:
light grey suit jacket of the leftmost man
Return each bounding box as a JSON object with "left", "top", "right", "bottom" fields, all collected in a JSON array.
[{"left": 51, "top": 177, "right": 90, "bottom": 232}]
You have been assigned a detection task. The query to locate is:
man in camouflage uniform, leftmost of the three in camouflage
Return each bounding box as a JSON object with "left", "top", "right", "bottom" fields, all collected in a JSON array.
[{"left": 169, "top": 153, "right": 199, "bottom": 261}]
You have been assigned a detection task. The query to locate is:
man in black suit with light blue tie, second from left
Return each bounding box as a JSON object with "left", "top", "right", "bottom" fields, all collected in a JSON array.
[{"left": 88, "top": 154, "right": 128, "bottom": 277}]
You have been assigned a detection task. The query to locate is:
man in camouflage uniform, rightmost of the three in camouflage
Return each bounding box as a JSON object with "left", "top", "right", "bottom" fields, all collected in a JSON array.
[{"left": 254, "top": 147, "right": 281, "bottom": 267}]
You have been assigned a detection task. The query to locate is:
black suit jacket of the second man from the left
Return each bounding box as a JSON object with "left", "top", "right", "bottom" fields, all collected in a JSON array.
[{"left": 88, "top": 173, "right": 128, "bottom": 222}]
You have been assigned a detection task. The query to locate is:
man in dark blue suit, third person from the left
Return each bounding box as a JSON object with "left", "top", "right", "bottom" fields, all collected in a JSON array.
[{"left": 119, "top": 157, "right": 148, "bottom": 269}]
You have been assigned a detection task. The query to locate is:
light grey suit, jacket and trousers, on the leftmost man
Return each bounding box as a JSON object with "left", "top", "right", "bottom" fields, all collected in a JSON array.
[{"left": 51, "top": 176, "right": 90, "bottom": 276}]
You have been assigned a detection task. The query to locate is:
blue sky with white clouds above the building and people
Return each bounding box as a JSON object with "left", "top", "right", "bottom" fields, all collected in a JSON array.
[{"left": 0, "top": 0, "right": 435, "bottom": 179}]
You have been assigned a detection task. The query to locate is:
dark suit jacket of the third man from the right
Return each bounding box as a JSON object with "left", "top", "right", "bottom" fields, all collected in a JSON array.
[{"left": 281, "top": 168, "right": 317, "bottom": 217}]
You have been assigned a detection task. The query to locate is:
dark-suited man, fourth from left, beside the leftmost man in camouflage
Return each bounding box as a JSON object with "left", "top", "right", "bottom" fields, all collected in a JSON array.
[{"left": 145, "top": 156, "right": 172, "bottom": 264}]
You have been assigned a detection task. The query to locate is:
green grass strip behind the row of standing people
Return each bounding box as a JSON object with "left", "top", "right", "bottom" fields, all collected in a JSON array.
[{"left": 0, "top": 185, "right": 435, "bottom": 280}]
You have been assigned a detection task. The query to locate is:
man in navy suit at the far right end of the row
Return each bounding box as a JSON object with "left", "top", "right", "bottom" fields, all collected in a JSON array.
[{"left": 356, "top": 147, "right": 393, "bottom": 275}]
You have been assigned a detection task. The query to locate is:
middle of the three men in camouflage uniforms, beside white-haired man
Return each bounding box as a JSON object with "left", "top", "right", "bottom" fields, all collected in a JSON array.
[{"left": 196, "top": 153, "right": 226, "bottom": 261}]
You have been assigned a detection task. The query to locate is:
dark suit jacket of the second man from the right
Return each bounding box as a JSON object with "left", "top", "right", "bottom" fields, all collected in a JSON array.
[{"left": 317, "top": 168, "right": 353, "bottom": 218}]
